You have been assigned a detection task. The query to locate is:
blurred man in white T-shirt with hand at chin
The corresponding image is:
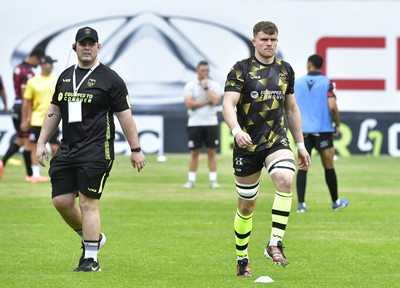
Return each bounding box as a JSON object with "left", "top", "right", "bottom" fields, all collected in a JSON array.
[{"left": 183, "top": 61, "right": 221, "bottom": 188}]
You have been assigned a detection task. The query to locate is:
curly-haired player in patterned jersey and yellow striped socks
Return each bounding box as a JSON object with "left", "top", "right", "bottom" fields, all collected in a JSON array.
[{"left": 222, "top": 21, "right": 311, "bottom": 277}]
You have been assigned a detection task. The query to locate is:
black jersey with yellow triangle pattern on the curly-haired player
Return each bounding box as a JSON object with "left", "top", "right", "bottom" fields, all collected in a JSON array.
[{"left": 225, "top": 57, "right": 295, "bottom": 152}]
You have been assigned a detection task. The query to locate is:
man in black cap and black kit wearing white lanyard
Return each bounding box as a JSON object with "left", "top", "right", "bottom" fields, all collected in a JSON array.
[{"left": 36, "top": 27, "right": 146, "bottom": 272}]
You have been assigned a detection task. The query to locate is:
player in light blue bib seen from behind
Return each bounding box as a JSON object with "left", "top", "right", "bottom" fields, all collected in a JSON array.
[{"left": 294, "top": 54, "right": 349, "bottom": 213}]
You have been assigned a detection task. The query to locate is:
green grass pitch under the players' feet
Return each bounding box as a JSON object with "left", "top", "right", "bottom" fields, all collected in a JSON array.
[{"left": 0, "top": 154, "right": 400, "bottom": 288}]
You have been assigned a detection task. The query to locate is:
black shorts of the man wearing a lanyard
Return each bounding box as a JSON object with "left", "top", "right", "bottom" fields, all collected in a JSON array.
[{"left": 49, "top": 156, "right": 113, "bottom": 199}]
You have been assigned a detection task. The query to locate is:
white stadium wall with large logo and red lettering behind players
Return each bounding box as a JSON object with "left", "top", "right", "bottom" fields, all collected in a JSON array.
[{"left": 0, "top": 0, "right": 400, "bottom": 157}]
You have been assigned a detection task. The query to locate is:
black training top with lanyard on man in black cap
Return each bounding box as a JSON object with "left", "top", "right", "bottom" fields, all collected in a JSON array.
[{"left": 51, "top": 64, "right": 130, "bottom": 161}]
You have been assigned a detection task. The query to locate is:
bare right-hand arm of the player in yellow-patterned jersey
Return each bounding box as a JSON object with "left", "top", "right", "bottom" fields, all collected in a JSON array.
[{"left": 285, "top": 94, "right": 311, "bottom": 170}]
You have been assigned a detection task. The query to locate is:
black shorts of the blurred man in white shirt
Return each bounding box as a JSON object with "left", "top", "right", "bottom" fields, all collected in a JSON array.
[{"left": 187, "top": 125, "right": 219, "bottom": 149}]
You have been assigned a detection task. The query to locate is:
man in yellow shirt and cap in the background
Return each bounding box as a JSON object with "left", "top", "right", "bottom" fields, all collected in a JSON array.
[{"left": 21, "top": 56, "right": 59, "bottom": 183}]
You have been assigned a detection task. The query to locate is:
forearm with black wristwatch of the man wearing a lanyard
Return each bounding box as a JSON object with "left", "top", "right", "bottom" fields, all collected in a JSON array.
[{"left": 115, "top": 109, "right": 146, "bottom": 172}]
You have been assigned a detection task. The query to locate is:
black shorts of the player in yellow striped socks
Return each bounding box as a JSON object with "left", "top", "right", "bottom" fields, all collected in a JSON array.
[{"left": 233, "top": 142, "right": 291, "bottom": 177}]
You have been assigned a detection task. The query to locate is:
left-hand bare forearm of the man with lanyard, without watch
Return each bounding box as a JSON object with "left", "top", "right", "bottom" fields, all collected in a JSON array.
[{"left": 36, "top": 104, "right": 61, "bottom": 167}]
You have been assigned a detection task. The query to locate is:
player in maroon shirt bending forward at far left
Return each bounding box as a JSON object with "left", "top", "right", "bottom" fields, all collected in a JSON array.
[{"left": 0, "top": 48, "right": 44, "bottom": 181}]
